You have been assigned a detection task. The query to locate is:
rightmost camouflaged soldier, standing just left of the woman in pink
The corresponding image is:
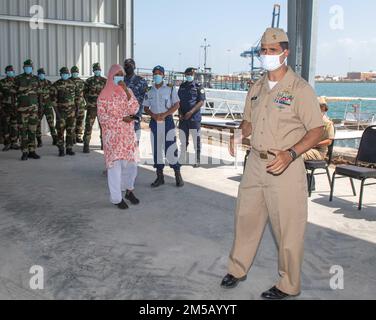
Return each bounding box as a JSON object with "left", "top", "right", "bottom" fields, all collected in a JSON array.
[{"left": 84, "top": 63, "right": 107, "bottom": 153}]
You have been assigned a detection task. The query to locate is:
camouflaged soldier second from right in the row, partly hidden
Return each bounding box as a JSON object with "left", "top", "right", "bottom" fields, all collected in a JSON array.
[{"left": 71, "top": 66, "right": 86, "bottom": 143}]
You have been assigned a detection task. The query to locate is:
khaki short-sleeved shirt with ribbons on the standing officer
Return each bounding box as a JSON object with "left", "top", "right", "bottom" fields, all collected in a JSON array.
[{"left": 244, "top": 67, "right": 324, "bottom": 152}]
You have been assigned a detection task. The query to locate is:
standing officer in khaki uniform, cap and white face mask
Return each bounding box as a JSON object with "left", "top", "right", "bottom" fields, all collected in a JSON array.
[{"left": 222, "top": 28, "right": 324, "bottom": 300}]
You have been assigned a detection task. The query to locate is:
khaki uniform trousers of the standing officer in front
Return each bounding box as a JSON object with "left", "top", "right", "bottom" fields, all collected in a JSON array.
[{"left": 229, "top": 150, "right": 308, "bottom": 295}]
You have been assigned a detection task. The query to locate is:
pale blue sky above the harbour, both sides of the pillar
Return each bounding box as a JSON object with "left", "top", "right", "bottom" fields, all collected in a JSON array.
[{"left": 135, "top": 0, "right": 376, "bottom": 74}]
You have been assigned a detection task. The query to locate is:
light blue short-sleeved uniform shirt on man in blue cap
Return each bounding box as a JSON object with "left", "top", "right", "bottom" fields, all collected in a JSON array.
[{"left": 143, "top": 83, "right": 180, "bottom": 114}]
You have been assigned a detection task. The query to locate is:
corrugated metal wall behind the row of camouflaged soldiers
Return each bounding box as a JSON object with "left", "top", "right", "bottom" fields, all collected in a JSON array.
[{"left": 0, "top": 0, "right": 134, "bottom": 79}]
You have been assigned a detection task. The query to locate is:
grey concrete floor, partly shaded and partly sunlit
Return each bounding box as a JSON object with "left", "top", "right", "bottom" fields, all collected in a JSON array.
[{"left": 0, "top": 132, "right": 376, "bottom": 300}]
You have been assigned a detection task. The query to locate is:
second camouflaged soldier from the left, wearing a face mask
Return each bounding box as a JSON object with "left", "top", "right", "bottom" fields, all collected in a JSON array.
[{"left": 15, "top": 60, "right": 40, "bottom": 161}]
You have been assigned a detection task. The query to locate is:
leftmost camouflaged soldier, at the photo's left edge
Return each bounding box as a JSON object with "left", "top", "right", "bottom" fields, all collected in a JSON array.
[{"left": 0, "top": 66, "right": 20, "bottom": 151}]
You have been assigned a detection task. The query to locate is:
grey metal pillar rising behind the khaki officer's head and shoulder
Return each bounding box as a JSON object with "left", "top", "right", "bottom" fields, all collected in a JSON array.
[{"left": 288, "top": 0, "right": 318, "bottom": 86}]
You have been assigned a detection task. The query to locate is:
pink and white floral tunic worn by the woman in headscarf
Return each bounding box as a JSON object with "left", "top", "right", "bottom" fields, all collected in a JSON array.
[{"left": 98, "top": 89, "right": 139, "bottom": 169}]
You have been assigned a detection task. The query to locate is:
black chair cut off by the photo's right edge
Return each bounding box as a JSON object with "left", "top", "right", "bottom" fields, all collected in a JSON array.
[{"left": 330, "top": 126, "right": 376, "bottom": 211}]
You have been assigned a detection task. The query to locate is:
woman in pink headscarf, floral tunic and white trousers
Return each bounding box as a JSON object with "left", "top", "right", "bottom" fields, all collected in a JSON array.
[{"left": 98, "top": 64, "right": 140, "bottom": 210}]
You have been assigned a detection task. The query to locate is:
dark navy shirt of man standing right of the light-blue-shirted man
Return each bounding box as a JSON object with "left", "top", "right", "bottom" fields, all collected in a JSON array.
[{"left": 178, "top": 81, "right": 206, "bottom": 121}]
